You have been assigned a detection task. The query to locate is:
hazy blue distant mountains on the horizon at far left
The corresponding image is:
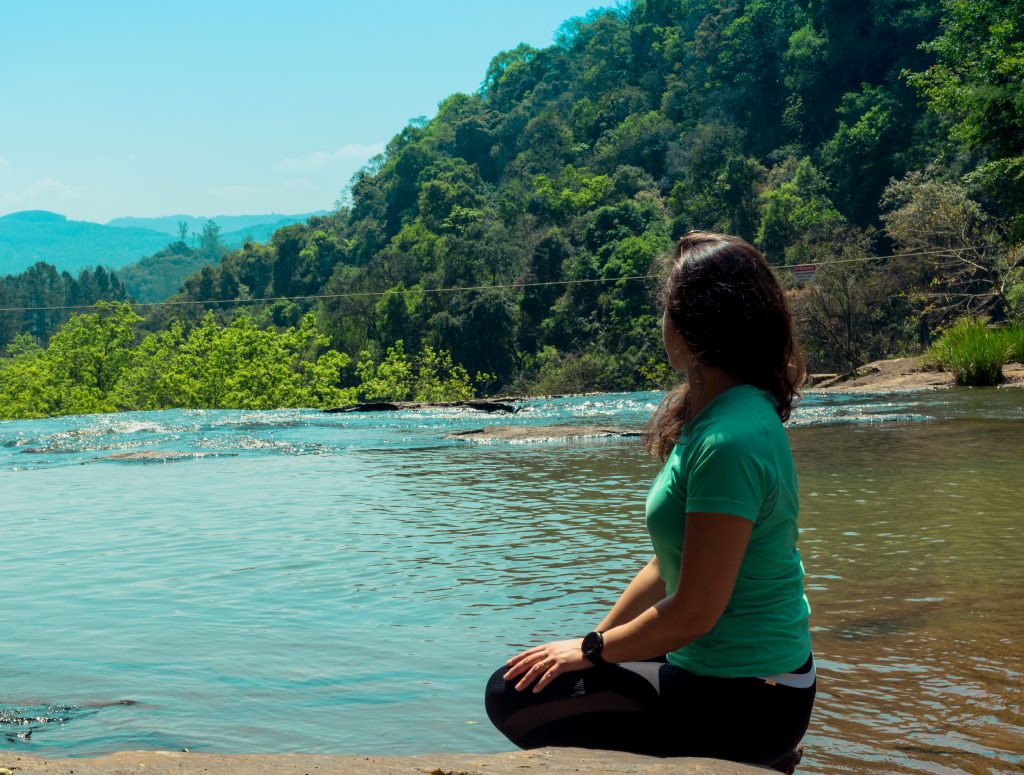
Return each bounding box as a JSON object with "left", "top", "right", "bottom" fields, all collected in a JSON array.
[{"left": 0, "top": 210, "right": 323, "bottom": 275}]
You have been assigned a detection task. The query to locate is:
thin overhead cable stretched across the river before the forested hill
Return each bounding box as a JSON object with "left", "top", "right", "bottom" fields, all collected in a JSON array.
[{"left": 0, "top": 248, "right": 970, "bottom": 312}]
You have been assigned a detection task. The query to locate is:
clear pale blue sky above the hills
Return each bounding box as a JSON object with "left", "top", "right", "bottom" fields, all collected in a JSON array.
[{"left": 0, "top": 0, "right": 608, "bottom": 222}]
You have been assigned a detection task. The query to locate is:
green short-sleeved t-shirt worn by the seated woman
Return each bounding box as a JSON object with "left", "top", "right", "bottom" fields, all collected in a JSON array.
[{"left": 647, "top": 385, "right": 811, "bottom": 678}]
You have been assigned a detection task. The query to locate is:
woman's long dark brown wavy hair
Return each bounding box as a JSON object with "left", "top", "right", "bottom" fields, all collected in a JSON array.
[{"left": 644, "top": 231, "right": 806, "bottom": 461}]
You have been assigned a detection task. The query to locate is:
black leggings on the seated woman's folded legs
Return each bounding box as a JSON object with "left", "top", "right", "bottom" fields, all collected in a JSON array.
[{"left": 485, "top": 658, "right": 815, "bottom": 765}]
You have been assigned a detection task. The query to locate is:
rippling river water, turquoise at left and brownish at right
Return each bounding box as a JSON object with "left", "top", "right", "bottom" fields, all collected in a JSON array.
[{"left": 0, "top": 389, "right": 1024, "bottom": 772}]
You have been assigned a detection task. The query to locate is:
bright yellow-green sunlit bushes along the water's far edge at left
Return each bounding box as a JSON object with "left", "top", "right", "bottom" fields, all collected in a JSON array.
[{"left": 0, "top": 304, "right": 477, "bottom": 419}]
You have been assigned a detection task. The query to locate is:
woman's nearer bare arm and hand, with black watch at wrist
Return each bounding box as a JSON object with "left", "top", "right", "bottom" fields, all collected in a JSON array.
[{"left": 505, "top": 512, "right": 754, "bottom": 692}]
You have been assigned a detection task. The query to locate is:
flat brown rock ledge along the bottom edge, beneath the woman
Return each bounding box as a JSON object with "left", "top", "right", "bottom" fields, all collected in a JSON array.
[{"left": 0, "top": 748, "right": 770, "bottom": 775}]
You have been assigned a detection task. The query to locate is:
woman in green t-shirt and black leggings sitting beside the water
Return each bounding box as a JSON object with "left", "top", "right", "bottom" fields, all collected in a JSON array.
[{"left": 486, "top": 232, "right": 816, "bottom": 772}]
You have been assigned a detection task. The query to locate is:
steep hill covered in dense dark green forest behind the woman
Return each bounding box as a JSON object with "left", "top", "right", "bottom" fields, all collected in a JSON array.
[{"left": 112, "top": 0, "right": 1024, "bottom": 389}]
